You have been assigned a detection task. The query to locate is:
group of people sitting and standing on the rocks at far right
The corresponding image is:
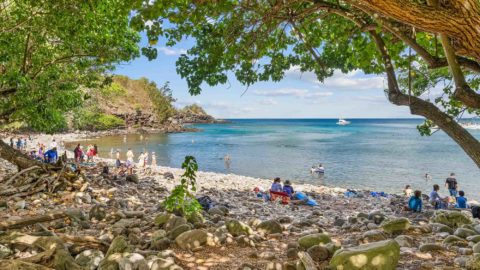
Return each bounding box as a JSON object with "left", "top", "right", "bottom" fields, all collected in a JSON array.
[{"left": 404, "top": 173, "right": 469, "bottom": 212}]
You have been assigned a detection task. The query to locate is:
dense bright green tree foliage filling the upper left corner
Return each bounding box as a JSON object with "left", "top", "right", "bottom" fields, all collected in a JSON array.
[{"left": 0, "top": 0, "right": 140, "bottom": 132}]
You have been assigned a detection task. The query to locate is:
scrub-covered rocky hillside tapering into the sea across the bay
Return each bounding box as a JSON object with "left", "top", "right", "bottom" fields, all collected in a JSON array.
[{"left": 72, "top": 76, "right": 215, "bottom": 132}]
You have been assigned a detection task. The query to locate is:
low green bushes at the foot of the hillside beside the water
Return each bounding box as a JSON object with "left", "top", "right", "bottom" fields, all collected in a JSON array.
[{"left": 73, "top": 111, "right": 125, "bottom": 130}]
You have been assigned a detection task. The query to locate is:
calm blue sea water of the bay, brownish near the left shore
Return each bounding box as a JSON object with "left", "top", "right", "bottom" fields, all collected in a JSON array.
[{"left": 69, "top": 119, "right": 480, "bottom": 199}]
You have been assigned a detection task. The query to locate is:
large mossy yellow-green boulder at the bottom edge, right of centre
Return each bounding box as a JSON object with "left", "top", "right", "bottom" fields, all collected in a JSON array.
[{"left": 330, "top": 240, "right": 400, "bottom": 270}]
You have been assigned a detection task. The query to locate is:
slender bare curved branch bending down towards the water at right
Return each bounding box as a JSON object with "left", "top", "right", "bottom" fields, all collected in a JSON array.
[{"left": 369, "top": 31, "right": 480, "bottom": 168}]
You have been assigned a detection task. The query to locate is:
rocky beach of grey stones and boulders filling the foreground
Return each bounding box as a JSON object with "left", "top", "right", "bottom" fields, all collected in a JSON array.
[{"left": 0, "top": 134, "right": 480, "bottom": 270}]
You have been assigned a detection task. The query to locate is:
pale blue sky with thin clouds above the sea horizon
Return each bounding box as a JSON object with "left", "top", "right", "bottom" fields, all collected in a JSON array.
[{"left": 114, "top": 38, "right": 418, "bottom": 118}]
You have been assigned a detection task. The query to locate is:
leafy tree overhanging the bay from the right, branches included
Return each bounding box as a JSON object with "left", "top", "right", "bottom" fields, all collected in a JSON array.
[{"left": 131, "top": 0, "right": 480, "bottom": 166}]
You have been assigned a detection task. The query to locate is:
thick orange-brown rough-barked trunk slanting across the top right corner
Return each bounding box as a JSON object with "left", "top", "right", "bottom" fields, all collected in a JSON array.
[{"left": 347, "top": 0, "right": 480, "bottom": 60}]
